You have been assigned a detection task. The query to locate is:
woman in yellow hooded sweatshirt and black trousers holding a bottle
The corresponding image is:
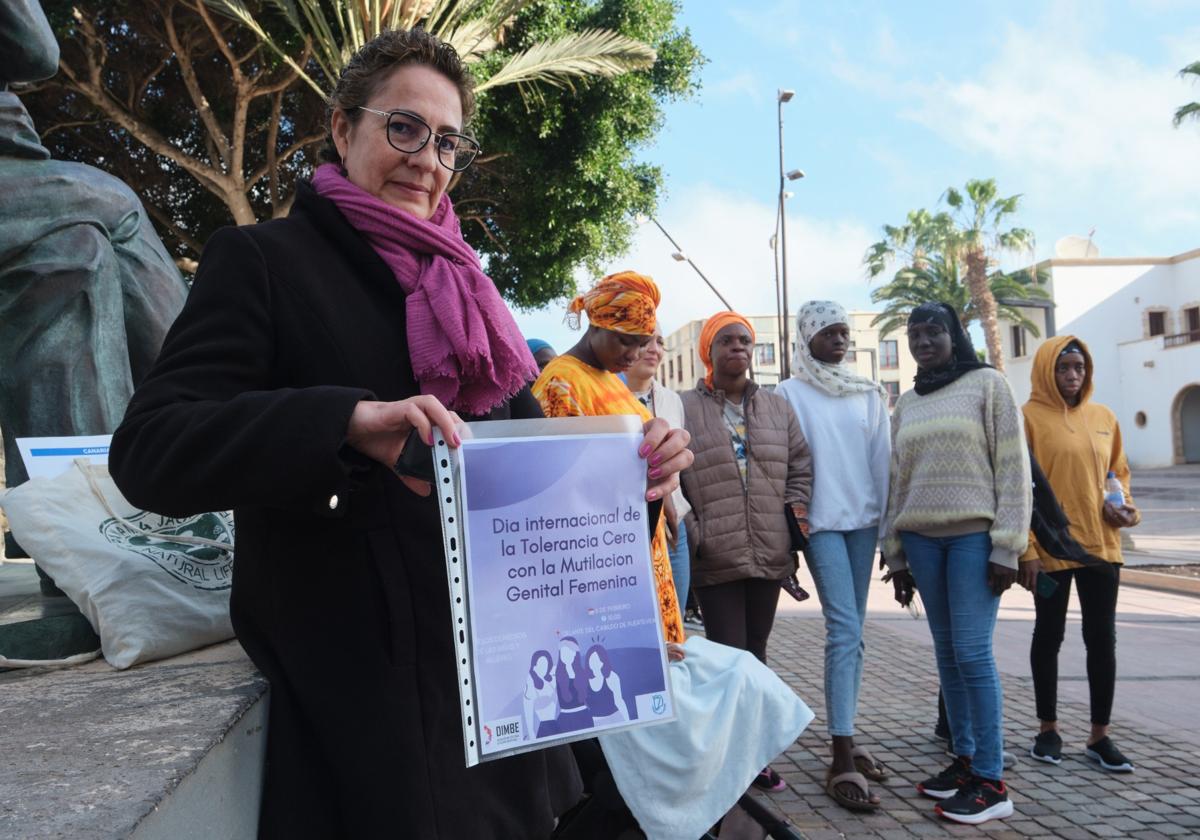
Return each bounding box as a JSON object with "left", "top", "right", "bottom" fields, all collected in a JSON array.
[{"left": 1020, "top": 336, "right": 1140, "bottom": 773}]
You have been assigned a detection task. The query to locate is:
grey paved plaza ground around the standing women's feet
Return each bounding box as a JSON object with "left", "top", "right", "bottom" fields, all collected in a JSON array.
[{"left": 748, "top": 568, "right": 1200, "bottom": 840}]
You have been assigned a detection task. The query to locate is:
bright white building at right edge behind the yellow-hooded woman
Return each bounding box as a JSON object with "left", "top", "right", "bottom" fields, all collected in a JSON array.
[{"left": 1002, "top": 248, "right": 1200, "bottom": 468}]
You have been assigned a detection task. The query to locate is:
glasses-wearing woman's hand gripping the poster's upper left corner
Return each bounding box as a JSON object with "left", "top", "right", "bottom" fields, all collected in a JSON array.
[{"left": 346, "top": 394, "right": 462, "bottom": 496}]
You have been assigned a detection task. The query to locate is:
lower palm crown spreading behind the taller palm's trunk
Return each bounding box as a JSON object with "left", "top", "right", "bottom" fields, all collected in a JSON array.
[{"left": 871, "top": 253, "right": 1050, "bottom": 337}]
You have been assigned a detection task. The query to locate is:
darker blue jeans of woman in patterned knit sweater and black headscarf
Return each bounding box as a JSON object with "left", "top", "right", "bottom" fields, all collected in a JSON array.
[{"left": 900, "top": 532, "right": 1004, "bottom": 779}]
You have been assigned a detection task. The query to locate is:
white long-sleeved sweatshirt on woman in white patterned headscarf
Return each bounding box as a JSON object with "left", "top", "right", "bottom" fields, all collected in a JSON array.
[{"left": 775, "top": 378, "right": 892, "bottom": 532}]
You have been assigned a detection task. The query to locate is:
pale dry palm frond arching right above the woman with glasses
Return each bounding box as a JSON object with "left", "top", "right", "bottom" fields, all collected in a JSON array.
[{"left": 475, "top": 29, "right": 658, "bottom": 94}]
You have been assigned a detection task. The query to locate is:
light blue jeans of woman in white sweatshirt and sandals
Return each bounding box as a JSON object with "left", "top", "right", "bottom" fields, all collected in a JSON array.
[{"left": 804, "top": 528, "right": 878, "bottom": 736}]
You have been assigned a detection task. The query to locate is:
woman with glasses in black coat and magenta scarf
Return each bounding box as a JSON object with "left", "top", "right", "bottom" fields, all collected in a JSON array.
[{"left": 110, "top": 30, "right": 690, "bottom": 839}]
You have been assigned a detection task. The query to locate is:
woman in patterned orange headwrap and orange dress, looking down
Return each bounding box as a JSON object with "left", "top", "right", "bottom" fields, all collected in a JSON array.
[{"left": 533, "top": 271, "right": 684, "bottom": 642}]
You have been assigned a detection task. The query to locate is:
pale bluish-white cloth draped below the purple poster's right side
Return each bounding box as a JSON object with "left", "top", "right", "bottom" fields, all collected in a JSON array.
[{"left": 599, "top": 636, "right": 812, "bottom": 840}]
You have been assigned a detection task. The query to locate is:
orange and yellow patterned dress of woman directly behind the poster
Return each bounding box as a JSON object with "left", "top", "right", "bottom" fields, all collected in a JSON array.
[{"left": 533, "top": 355, "right": 684, "bottom": 642}]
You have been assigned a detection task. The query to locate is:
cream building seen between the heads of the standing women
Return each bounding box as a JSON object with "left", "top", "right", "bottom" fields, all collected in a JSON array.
[{"left": 659, "top": 311, "right": 917, "bottom": 403}]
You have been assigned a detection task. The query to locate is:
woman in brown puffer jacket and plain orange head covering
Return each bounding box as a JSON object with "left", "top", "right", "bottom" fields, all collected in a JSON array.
[{"left": 683, "top": 312, "right": 812, "bottom": 791}]
